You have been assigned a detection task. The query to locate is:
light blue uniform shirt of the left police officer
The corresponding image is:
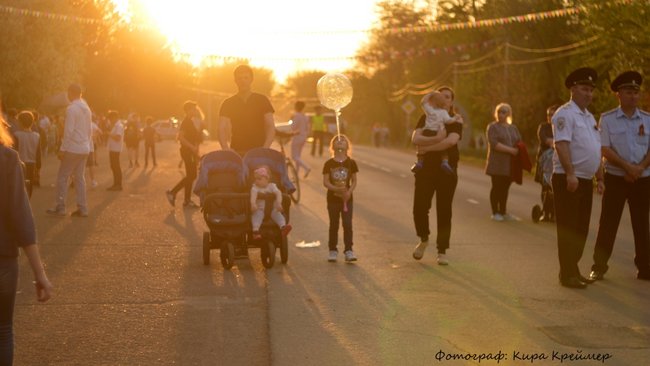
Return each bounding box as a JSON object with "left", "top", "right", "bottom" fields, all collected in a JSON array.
[{"left": 552, "top": 101, "right": 600, "bottom": 179}]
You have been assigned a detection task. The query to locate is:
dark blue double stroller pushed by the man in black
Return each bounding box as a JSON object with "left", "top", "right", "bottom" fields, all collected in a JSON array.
[{"left": 194, "top": 148, "right": 293, "bottom": 269}]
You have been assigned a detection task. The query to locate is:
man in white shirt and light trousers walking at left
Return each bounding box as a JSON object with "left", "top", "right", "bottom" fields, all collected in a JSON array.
[{"left": 47, "top": 84, "right": 92, "bottom": 217}]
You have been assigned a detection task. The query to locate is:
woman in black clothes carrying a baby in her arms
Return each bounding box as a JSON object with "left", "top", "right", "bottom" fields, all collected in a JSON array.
[{"left": 411, "top": 86, "right": 463, "bottom": 265}]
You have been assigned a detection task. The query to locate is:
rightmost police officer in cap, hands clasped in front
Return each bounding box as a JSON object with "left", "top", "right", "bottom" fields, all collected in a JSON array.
[{"left": 589, "top": 71, "right": 650, "bottom": 280}]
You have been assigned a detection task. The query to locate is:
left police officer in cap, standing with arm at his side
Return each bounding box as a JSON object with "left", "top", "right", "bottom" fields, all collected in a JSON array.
[{"left": 552, "top": 67, "right": 604, "bottom": 288}]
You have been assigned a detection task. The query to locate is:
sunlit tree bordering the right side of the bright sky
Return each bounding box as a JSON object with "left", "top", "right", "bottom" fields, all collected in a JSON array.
[{"left": 344, "top": 0, "right": 433, "bottom": 143}]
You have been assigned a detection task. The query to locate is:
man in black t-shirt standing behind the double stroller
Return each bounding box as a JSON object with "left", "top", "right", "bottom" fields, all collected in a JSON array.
[{"left": 219, "top": 65, "right": 275, "bottom": 156}]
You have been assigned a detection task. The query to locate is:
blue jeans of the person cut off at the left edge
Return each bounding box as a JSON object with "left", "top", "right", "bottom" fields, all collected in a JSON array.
[{"left": 0, "top": 257, "right": 18, "bottom": 366}]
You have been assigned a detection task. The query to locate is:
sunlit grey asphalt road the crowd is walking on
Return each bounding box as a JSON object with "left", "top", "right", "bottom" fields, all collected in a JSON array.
[{"left": 15, "top": 141, "right": 650, "bottom": 365}]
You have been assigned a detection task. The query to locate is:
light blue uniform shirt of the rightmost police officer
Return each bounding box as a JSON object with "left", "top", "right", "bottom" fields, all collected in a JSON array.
[{"left": 600, "top": 107, "right": 650, "bottom": 177}]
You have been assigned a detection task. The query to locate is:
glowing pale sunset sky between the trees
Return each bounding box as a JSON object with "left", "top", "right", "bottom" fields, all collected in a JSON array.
[{"left": 113, "top": 0, "right": 432, "bottom": 81}]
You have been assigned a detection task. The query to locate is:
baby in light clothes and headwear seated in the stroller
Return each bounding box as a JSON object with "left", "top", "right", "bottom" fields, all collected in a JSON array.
[{"left": 251, "top": 165, "right": 291, "bottom": 240}]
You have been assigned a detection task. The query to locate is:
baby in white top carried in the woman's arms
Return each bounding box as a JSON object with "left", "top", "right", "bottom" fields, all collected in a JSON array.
[{"left": 411, "top": 91, "right": 460, "bottom": 174}]
